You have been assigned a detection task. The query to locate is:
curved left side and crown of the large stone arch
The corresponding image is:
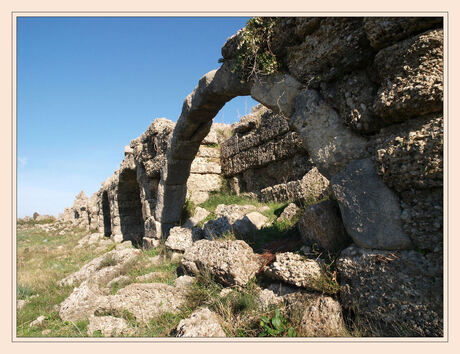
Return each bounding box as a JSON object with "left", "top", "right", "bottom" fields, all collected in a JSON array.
[{"left": 155, "top": 60, "right": 302, "bottom": 236}]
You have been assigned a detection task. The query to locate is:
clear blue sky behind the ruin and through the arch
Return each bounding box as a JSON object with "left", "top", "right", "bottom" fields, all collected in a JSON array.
[{"left": 17, "top": 17, "right": 257, "bottom": 217}]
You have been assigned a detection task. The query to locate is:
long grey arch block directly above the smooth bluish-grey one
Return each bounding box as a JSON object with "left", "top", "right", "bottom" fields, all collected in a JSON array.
[{"left": 290, "top": 90, "right": 366, "bottom": 178}]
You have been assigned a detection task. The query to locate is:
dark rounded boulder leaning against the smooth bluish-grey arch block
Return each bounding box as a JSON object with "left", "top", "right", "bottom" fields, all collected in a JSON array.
[{"left": 298, "top": 200, "right": 351, "bottom": 252}]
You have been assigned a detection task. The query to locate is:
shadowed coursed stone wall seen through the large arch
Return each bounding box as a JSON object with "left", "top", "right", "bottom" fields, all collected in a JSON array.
[{"left": 221, "top": 105, "right": 329, "bottom": 202}]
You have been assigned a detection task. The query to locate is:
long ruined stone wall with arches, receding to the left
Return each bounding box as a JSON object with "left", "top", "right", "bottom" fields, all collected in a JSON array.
[{"left": 61, "top": 17, "right": 444, "bottom": 336}]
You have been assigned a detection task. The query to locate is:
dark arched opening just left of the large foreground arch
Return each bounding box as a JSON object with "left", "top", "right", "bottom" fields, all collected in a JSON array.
[{"left": 118, "top": 169, "right": 144, "bottom": 244}]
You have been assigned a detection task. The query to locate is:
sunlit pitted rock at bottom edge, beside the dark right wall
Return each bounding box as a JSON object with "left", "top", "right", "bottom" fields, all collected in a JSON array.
[{"left": 283, "top": 293, "right": 348, "bottom": 337}]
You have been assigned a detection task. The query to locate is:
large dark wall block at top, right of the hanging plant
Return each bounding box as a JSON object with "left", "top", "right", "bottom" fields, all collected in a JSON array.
[{"left": 286, "top": 17, "right": 373, "bottom": 84}]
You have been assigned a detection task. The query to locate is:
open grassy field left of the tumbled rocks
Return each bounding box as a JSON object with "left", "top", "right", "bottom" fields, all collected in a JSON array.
[{"left": 17, "top": 223, "right": 103, "bottom": 337}]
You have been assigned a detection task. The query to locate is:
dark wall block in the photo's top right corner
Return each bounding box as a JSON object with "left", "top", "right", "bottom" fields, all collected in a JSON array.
[{"left": 363, "top": 17, "right": 442, "bottom": 49}]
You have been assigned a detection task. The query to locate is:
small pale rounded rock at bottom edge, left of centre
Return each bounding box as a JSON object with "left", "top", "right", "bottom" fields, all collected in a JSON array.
[{"left": 176, "top": 308, "right": 225, "bottom": 338}]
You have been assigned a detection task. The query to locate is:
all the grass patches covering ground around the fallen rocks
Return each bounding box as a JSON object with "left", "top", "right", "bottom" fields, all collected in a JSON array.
[{"left": 17, "top": 187, "right": 359, "bottom": 337}]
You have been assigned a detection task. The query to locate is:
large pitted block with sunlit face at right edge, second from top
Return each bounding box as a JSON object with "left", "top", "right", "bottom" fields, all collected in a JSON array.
[{"left": 374, "top": 29, "right": 444, "bottom": 123}]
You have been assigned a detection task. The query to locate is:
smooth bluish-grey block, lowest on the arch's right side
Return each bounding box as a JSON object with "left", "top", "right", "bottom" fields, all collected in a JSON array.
[{"left": 331, "top": 159, "right": 411, "bottom": 250}]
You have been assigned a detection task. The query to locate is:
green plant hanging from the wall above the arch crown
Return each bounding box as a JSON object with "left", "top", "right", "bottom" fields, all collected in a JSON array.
[{"left": 227, "top": 17, "right": 280, "bottom": 81}]
